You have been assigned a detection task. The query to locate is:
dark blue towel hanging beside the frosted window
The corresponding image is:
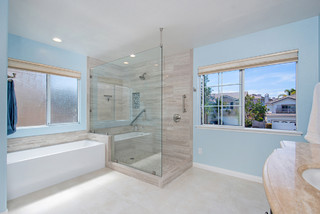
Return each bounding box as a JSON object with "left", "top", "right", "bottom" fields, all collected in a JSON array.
[{"left": 7, "top": 80, "right": 18, "bottom": 135}]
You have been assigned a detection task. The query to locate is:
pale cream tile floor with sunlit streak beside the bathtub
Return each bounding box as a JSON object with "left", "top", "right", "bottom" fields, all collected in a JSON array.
[{"left": 8, "top": 167, "right": 269, "bottom": 214}]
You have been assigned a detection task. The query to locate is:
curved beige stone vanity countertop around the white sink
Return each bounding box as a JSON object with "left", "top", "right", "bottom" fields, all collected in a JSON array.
[{"left": 263, "top": 141, "right": 320, "bottom": 214}]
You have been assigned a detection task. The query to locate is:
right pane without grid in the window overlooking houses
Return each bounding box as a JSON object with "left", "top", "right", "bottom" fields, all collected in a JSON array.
[{"left": 245, "top": 62, "right": 296, "bottom": 130}]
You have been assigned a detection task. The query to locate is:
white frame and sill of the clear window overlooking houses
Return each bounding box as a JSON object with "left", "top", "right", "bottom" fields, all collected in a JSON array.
[{"left": 196, "top": 50, "right": 303, "bottom": 136}]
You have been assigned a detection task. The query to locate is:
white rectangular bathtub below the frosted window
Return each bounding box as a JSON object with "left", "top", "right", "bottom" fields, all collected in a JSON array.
[{"left": 7, "top": 140, "right": 105, "bottom": 200}]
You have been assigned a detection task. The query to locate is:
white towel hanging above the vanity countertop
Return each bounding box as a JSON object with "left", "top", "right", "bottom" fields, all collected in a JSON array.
[{"left": 304, "top": 83, "right": 320, "bottom": 144}]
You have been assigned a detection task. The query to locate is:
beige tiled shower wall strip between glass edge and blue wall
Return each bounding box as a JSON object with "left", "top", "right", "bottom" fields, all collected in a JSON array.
[{"left": 163, "top": 50, "right": 193, "bottom": 163}]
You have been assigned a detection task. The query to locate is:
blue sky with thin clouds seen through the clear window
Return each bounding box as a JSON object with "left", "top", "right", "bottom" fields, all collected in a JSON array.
[{"left": 207, "top": 62, "right": 296, "bottom": 98}]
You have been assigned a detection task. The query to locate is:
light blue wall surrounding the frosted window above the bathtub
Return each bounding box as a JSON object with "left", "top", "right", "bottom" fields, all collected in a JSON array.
[{"left": 8, "top": 34, "right": 87, "bottom": 138}]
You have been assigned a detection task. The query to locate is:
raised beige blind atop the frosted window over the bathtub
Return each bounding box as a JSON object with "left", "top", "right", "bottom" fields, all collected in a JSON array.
[{"left": 8, "top": 58, "right": 81, "bottom": 79}]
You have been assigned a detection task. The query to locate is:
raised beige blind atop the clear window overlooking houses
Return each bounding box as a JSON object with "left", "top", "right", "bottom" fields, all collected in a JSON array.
[{"left": 198, "top": 50, "right": 298, "bottom": 76}]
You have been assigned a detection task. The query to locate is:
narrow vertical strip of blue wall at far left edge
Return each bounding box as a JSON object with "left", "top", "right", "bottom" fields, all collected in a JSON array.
[{"left": 0, "top": 0, "right": 8, "bottom": 213}]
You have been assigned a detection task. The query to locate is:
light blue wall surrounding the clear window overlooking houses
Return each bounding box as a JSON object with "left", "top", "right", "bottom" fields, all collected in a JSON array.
[{"left": 193, "top": 17, "right": 319, "bottom": 176}]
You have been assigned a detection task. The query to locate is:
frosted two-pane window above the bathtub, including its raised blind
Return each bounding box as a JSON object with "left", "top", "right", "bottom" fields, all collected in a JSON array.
[{"left": 8, "top": 59, "right": 79, "bottom": 127}]
